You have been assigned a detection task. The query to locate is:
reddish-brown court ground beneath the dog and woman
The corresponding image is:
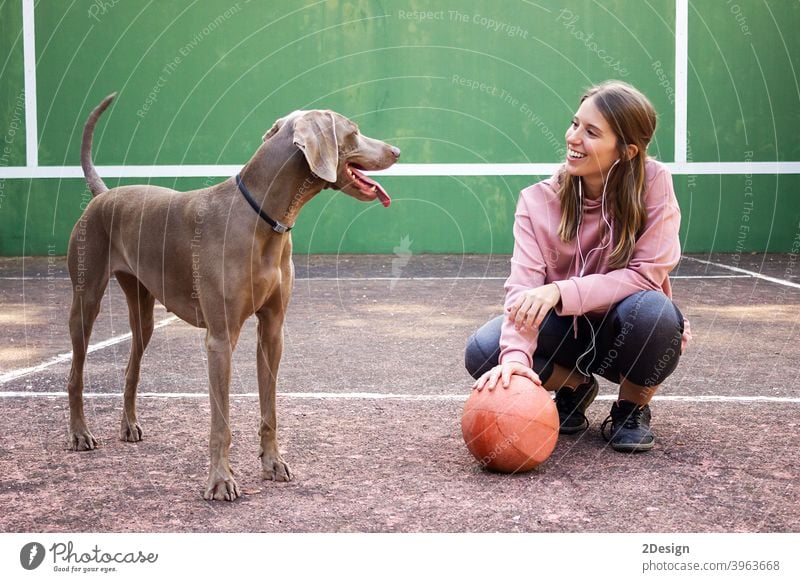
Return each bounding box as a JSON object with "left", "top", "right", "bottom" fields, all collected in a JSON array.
[{"left": 0, "top": 254, "right": 800, "bottom": 533}]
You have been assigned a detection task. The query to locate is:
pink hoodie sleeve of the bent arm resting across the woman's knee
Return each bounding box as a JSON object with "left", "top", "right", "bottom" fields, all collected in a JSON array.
[{"left": 555, "top": 165, "right": 681, "bottom": 315}]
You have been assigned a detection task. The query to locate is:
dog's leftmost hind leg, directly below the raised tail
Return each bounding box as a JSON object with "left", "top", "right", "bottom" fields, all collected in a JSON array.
[{"left": 67, "top": 228, "right": 109, "bottom": 451}]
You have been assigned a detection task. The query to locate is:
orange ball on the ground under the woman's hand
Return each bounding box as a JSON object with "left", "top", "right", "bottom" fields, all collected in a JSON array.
[{"left": 461, "top": 374, "right": 558, "bottom": 473}]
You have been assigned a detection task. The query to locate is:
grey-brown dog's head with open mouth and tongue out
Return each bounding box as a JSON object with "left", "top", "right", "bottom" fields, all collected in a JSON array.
[{"left": 264, "top": 110, "right": 400, "bottom": 206}]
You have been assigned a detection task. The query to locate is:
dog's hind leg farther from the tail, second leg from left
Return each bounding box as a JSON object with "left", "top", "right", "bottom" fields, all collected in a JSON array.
[{"left": 115, "top": 273, "right": 155, "bottom": 442}]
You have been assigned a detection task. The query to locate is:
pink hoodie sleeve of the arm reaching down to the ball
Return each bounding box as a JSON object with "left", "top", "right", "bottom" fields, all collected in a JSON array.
[{"left": 500, "top": 191, "right": 546, "bottom": 366}]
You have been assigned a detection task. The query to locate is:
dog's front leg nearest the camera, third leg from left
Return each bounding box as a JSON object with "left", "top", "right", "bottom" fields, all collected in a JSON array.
[{"left": 203, "top": 330, "right": 241, "bottom": 501}]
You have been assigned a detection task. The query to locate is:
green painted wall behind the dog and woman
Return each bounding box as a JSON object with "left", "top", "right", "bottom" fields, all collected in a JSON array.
[{"left": 0, "top": 0, "right": 800, "bottom": 255}]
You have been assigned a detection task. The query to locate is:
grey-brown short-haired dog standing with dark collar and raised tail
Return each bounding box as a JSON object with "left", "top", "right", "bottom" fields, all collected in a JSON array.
[{"left": 67, "top": 94, "right": 400, "bottom": 501}]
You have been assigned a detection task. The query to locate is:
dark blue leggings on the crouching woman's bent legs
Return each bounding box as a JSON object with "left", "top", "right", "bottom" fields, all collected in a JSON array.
[{"left": 464, "top": 291, "right": 683, "bottom": 387}]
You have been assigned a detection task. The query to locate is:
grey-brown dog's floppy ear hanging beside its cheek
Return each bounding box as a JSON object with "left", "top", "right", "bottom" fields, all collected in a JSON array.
[{"left": 294, "top": 111, "right": 339, "bottom": 182}]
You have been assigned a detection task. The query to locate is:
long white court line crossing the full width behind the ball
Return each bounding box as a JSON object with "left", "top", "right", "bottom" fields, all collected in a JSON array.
[{"left": 0, "top": 391, "right": 800, "bottom": 404}]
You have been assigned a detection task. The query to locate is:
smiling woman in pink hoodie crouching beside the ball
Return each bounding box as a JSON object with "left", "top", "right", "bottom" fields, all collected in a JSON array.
[{"left": 465, "top": 81, "right": 691, "bottom": 452}]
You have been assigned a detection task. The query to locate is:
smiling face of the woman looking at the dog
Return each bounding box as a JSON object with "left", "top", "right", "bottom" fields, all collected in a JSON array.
[{"left": 566, "top": 97, "right": 619, "bottom": 185}]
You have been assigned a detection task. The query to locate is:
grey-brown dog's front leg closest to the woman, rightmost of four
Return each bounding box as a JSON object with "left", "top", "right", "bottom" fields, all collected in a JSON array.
[{"left": 256, "top": 309, "right": 292, "bottom": 481}]
